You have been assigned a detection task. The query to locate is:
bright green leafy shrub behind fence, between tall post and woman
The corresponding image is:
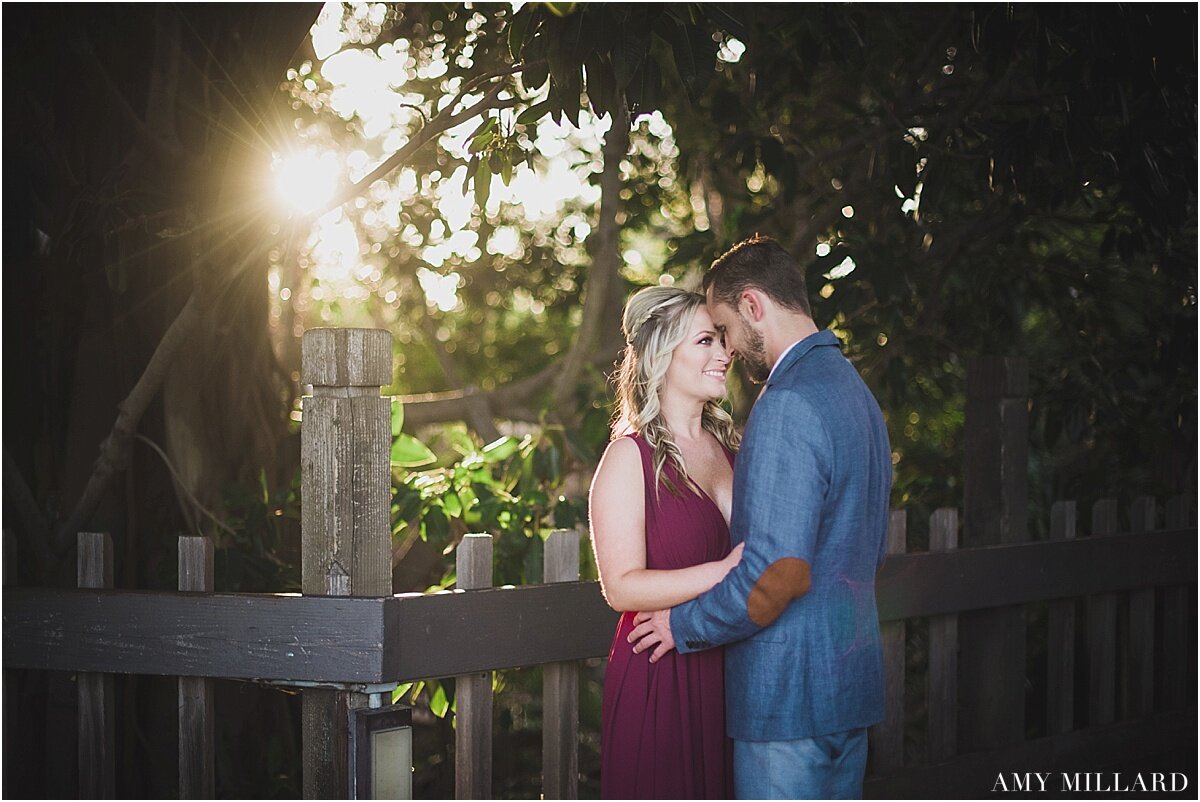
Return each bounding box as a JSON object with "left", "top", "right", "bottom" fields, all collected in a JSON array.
[{"left": 381, "top": 401, "right": 599, "bottom": 796}]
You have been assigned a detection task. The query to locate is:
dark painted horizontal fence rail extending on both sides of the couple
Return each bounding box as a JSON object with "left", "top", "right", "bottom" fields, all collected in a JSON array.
[{"left": 4, "top": 527, "right": 1196, "bottom": 684}]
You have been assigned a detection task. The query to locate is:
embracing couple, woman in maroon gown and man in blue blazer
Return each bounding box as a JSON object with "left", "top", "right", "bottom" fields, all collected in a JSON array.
[{"left": 590, "top": 237, "right": 892, "bottom": 798}]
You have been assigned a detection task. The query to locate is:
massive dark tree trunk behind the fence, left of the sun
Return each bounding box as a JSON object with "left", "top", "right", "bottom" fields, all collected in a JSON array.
[{"left": 4, "top": 5, "right": 319, "bottom": 797}]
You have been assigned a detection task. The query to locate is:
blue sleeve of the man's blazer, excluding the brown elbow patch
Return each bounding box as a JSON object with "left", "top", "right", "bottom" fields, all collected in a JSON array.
[{"left": 671, "top": 388, "right": 833, "bottom": 653}]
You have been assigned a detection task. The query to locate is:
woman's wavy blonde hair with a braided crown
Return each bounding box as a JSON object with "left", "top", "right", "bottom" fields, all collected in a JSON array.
[{"left": 612, "top": 287, "right": 742, "bottom": 496}]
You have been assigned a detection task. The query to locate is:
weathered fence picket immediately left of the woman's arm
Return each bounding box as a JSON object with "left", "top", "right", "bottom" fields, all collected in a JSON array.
[{"left": 541, "top": 529, "right": 580, "bottom": 800}]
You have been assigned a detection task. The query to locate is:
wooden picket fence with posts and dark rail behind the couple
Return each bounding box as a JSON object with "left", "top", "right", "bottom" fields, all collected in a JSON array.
[{"left": 4, "top": 330, "right": 1196, "bottom": 798}]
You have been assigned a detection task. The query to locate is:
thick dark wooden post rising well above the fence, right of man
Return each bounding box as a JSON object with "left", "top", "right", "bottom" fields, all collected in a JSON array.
[{"left": 959, "top": 357, "right": 1030, "bottom": 752}]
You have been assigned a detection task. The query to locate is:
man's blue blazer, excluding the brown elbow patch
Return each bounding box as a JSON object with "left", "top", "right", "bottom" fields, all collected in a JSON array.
[{"left": 671, "top": 331, "right": 892, "bottom": 741}]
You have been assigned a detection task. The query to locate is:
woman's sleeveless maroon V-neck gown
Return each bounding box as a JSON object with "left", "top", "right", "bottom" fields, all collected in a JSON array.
[{"left": 600, "top": 435, "right": 733, "bottom": 800}]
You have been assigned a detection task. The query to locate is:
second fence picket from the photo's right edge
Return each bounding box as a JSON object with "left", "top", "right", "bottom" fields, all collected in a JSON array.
[{"left": 1121, "top": 496, "right": 1158, "bottom": 718}]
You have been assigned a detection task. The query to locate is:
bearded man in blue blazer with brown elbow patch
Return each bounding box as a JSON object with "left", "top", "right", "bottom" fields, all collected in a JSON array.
[{"left": 630, "top": 237, "right": 892, "bottom": 798}]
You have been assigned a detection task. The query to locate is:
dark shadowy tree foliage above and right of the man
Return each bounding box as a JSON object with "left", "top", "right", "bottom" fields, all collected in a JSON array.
[{"left": 652, "top": 5, "right": 1195, "bottom": 529}]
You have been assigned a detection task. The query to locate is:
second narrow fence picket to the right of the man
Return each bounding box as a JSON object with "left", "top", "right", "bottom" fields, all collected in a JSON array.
[{"left": 928, "top": 509, "right": 959, "bottom": 762}]
